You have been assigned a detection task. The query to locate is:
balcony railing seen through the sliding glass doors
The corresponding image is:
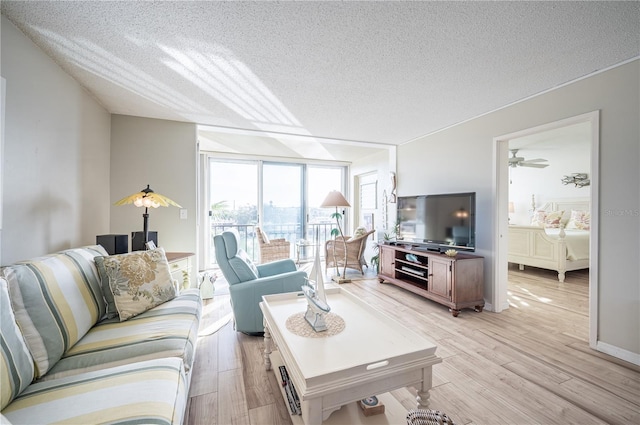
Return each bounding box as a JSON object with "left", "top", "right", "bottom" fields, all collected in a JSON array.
[{"left": 210, "top": 223, "right": 335, "bottom": 264}]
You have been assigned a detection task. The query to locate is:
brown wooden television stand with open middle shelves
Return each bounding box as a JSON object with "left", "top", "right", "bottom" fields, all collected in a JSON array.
[{"left": 378, "top": 244, "right": 484, "bottom": 317}]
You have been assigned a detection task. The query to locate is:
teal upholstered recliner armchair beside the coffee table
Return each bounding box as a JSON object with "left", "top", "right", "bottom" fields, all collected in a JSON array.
[{"left": 213, "top": 231, "right": 307, "bottom": 334}]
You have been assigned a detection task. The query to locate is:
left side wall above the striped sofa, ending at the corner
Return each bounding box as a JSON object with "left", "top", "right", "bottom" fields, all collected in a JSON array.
[{"left": 1, "top": 16, "right": 110, "bottom": 264}]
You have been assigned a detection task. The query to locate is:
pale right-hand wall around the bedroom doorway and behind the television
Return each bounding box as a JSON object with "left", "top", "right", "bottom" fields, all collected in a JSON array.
[{"left": 398, "top": 60, "right": 640, "bottom": 355}]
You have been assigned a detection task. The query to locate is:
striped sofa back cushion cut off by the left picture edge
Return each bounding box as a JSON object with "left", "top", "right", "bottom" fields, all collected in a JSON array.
[{"left": 0, "top": 277, "right": 35, "bottom": 410}]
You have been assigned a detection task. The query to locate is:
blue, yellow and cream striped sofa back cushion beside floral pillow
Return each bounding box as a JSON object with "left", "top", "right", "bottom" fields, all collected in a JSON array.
[{"left": 3, "top": 248, "right": 104, "bottom": 378}]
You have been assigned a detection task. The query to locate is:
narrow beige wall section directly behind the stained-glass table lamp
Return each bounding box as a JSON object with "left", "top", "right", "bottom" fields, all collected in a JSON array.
[{"left": 110, "top": 115, "right": 198, "bottom": 280}]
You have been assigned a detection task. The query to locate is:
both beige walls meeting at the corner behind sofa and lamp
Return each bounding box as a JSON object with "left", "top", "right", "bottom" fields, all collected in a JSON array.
[{"left": 0, "top": 16, "right": 197, "bottom": 276}]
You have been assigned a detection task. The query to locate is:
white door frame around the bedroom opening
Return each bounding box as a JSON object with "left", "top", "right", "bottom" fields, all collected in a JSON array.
[{"left": 491, "top": 110, "right": 600, "bottom": 349}]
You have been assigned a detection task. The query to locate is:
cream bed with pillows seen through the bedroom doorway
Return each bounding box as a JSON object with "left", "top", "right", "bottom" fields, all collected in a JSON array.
[{"left": 508, "top": 198, "right": 590, "bottom": 282}]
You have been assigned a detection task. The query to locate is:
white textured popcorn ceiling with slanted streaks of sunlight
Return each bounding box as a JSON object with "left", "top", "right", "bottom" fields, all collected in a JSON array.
[{"left": 2, "top": 1, "right": 640, "bottom": 156}]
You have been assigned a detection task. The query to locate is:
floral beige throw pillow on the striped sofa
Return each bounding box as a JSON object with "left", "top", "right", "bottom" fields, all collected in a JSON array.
[{"left": 103, "top": 248, "right": 176, "bottom": 322}]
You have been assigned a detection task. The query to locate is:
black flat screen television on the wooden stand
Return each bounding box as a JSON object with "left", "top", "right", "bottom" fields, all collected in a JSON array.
[{"left": 398, "top": 192, "right": 476, "bottom": 252}]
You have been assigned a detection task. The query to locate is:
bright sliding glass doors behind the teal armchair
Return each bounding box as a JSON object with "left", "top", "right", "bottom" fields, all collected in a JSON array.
[{"left": 205, "top": 157, "right": 346, "bottom": 267}]
